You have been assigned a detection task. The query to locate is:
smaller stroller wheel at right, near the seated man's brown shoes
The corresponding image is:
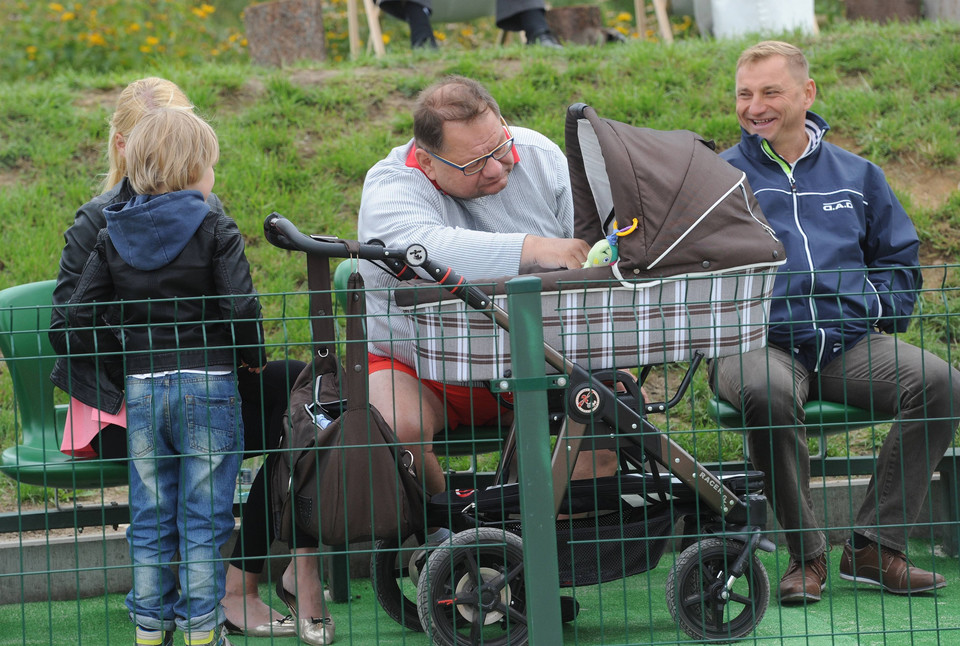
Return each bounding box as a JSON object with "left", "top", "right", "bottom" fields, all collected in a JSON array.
[{"left": 667, "top": 538, "right": 770, "bottom": 642}]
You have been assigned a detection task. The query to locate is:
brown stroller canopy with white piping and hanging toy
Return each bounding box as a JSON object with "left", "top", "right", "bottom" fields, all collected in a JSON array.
[{"left": 565, "top": 103, "right": 786, "bottom": 279}]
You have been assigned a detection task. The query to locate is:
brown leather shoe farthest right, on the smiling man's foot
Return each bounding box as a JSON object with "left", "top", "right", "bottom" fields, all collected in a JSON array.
[{"left": 840, "top": 543, "right": 947, "bottom": 594}]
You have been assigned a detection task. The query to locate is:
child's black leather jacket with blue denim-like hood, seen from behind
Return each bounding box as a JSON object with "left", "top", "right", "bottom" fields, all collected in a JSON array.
[{"left": 66, "top": 191, "right": 265, "bottom": 374}]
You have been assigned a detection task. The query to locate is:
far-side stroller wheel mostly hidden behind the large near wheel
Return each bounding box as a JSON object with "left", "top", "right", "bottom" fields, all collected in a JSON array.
[{"left": 370, "top": 540, "right": 423, "bottom": 632}]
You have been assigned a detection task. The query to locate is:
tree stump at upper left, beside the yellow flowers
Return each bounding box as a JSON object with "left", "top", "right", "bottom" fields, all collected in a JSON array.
[{"left": 243, "top": 0, "right": 327, "bottom": 66}]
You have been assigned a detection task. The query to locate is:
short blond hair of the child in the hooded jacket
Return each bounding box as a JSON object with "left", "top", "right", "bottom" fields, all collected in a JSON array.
[{"left": 126, "top": 108, "right": 220, "bottom": 195}]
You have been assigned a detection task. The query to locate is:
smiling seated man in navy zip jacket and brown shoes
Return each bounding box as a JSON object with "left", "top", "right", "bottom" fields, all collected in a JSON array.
[{"left": 711, "top": 41, "right": 960, "bottom": 603}]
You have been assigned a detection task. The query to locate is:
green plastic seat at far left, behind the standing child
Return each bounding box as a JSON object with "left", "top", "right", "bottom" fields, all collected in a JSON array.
[{"left": 0, "top": 280, "right": 127, "bottom": 489}]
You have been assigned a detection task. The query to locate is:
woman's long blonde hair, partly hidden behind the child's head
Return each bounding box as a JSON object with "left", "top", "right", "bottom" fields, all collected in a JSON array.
[{"left": 100, "top": 76, "right": 193, "bottom": 192}]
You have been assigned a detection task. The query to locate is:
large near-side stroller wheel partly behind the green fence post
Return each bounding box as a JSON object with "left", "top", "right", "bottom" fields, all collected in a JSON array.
[{"left": 417, "top": 527, "right": 528, "bottom": 646}]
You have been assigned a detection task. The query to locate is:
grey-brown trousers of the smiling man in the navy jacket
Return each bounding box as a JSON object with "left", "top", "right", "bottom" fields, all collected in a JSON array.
[{"left": 711, "top": 334, "right": 960, "bottom": 561}]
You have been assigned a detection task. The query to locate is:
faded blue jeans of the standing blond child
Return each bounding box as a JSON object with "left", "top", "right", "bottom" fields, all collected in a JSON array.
[{"left": 126, "top": 373, "right": 243, "bottom": 632}]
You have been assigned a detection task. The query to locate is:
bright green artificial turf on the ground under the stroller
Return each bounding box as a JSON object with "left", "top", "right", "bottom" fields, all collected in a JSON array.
[{"left": 0, "top": 542, "right": 960, "bottom": 646}]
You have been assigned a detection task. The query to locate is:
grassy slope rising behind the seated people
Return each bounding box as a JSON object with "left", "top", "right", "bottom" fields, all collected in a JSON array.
[{"left": 0, "top": 22, "right": 960, "bottom": 466}]
